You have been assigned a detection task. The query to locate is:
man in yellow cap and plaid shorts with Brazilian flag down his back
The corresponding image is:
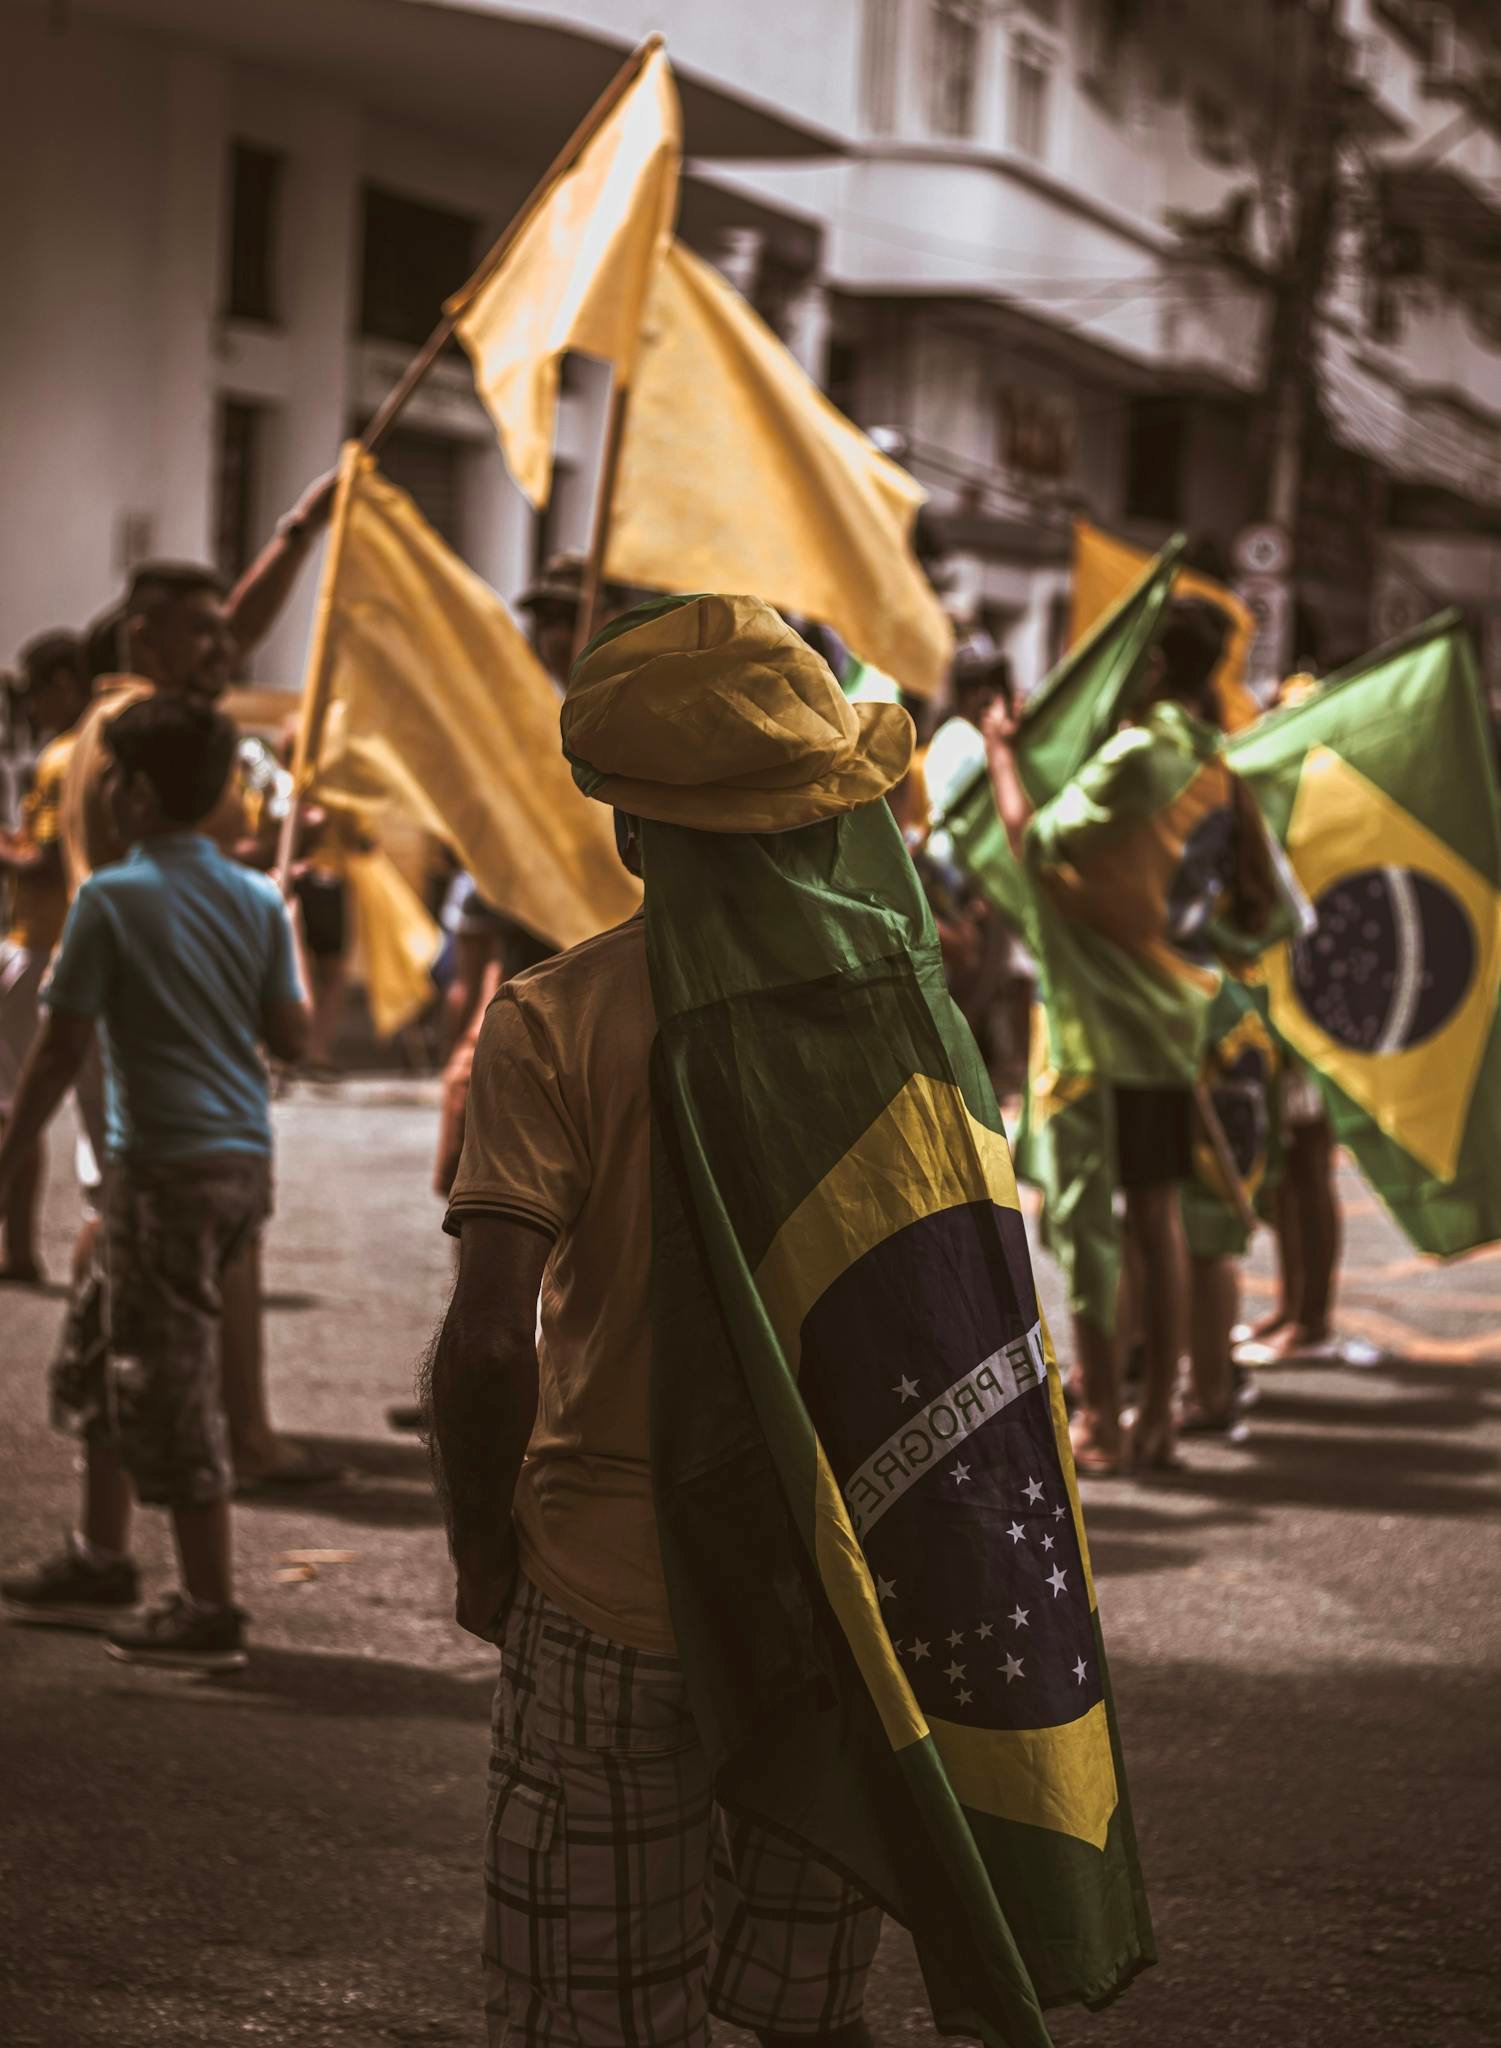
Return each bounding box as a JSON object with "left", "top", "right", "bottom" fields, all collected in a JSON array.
[{"left": 432, "top": 596, "right": 1153, "bottom": 2048}]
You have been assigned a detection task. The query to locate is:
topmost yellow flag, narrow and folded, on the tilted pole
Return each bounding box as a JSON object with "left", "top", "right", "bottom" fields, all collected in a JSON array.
[{"left": 446, "top": 51, "right": 682, "bottom": 506}]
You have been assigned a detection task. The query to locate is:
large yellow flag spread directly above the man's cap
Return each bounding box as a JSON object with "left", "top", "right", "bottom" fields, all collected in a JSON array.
[{"left": 606, "top": 242, "right": 954, "bottom": 696}]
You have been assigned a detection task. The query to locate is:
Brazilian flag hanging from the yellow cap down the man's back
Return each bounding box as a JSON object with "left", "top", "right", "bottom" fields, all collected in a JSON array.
[{"left": 641, "top": 803, "right": 1153, "bottom": 2048}]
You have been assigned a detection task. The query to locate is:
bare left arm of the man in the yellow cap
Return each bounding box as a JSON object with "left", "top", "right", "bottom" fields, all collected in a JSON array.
[{"left": 428, "top": 1212, "right": 553, "bottom": 1642}]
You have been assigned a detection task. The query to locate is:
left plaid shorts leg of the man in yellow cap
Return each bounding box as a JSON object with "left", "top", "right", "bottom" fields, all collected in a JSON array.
[{"left": 483, "top": 1579, "right": 711, "bottom": 2048}]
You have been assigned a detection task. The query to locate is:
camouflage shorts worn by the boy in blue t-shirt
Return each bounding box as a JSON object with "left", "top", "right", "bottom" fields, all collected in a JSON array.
[{"left": 51, "top": 1153, "right": 270, "bottom": 1507}]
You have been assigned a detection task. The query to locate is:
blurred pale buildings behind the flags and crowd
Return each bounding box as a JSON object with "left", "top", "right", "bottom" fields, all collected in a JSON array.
[{"left": 0, "top": 0, "right": 1501, "bottom": 694}]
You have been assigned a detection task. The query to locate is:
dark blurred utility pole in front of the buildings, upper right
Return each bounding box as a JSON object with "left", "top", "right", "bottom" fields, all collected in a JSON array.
[{"left": 1235, "top": 0, "right": 1343, "bottom": 686}]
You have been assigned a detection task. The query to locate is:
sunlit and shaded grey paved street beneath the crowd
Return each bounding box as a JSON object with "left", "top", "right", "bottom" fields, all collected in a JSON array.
[{"left": 0, "top": 1083, "right": 1501, "bottom": 2048}]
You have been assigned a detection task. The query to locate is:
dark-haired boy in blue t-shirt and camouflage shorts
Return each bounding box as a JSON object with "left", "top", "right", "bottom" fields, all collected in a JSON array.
[{"left": 0, "top": 692, "right": 309, "bottom": 1671}]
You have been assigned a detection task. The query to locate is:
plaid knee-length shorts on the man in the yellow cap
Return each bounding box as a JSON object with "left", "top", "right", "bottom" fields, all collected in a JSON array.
[{"left": 483, "top": 1579, "right": 881, "bottom": 2048}]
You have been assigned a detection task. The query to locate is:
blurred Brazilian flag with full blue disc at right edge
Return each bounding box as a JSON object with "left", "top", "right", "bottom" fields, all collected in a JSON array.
[{"left": 1229, "top": 612, "right": 1501, "bottom": 1257}]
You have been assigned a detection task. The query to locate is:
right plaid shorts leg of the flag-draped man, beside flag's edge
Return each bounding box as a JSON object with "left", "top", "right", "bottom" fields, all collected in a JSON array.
[{"left": 709, "top": 1810, "right": 881, "bottom": 2048}]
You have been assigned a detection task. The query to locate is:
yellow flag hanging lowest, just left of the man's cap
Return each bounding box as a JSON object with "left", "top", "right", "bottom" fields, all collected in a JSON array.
[{"left": 309, "top": 455, "right": 641, "bottom": 946}]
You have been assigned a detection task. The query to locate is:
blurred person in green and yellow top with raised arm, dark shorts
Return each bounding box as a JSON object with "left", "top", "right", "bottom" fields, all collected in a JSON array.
[{"left": 985, "top": 598, "right": 1276, "bottom": 1475}]
